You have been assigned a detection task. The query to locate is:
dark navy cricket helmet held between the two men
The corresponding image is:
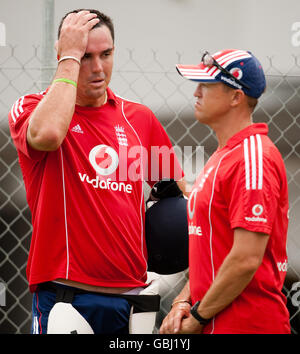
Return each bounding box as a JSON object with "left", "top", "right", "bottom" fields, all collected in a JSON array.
[{"left": 145, "top": 180, "right": 189, "bottom": 274}]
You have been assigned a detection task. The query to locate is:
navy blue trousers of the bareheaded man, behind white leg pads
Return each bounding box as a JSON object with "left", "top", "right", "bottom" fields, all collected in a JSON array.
[{"left": 31, "top": 285, "right": 131, "bottom": 334}]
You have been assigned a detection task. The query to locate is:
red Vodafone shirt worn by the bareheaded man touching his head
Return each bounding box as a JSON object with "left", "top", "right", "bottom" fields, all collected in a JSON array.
[{"left": 9, "top": 89, "right": 183, "bottom": 290}]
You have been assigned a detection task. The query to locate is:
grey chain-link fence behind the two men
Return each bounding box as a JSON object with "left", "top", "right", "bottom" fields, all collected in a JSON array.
[{"left": 0, "top": 46, "right": 300, "bottom": 334}]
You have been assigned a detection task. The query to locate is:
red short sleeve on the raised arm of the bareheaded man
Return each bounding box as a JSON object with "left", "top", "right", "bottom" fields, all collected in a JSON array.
[{"left": 8, "top": 95, "right": 45, "bottom": 160}]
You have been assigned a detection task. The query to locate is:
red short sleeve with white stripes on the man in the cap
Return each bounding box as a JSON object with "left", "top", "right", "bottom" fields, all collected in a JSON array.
[{"left": 222, "top": 152, "right": 280, "bottom": 234}]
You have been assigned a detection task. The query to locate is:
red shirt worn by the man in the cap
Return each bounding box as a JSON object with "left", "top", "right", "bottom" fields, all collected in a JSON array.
[{"left": 188, "top": 124, "right": 290, "bottom": 333}]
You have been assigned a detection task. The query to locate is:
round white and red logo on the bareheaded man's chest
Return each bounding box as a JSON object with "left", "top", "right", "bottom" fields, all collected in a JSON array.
[{"left": 89, "top": 144, "right": 119, "bottom": 176}]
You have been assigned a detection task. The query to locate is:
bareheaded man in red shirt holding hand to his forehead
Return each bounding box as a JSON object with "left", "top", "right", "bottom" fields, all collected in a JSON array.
[{"left": 9, "top": 10, "right": 184, "bottom": 333}]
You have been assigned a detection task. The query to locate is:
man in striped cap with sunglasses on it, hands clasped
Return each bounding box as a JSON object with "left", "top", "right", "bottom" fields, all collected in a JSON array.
[{"left": 160, "top": 50, "right": 290, "bottom": 333}]
